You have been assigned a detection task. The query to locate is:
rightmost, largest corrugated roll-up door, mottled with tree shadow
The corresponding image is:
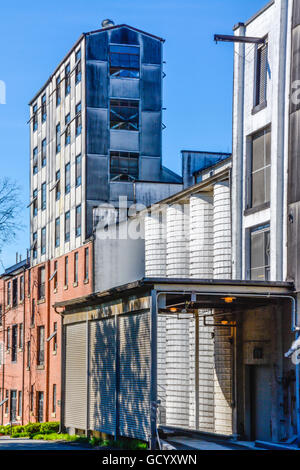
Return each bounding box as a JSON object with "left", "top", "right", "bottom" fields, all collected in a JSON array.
[{"left": 119, "top": 313, "right": 151, "bottom": 440}]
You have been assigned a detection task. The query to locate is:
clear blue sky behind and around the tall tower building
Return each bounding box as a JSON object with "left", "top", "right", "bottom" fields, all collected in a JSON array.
[{"left": 0, "top": 0, "right": 267, "bottom": 272}]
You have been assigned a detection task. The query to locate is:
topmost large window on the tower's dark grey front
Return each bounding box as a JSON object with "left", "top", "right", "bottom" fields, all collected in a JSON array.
[{"left": 109, "top": 44, "right": 140, "bottom": 78}]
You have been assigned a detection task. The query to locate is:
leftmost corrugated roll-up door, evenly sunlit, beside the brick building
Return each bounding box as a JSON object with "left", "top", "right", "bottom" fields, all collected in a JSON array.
[{"left": 65, "top": 323, "right": 87, "bottom": 429}]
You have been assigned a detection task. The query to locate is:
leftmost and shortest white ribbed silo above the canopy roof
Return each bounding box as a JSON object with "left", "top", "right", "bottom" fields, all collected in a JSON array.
[{"left": 145, "top": 212, "right": 166, "bottom": 277}]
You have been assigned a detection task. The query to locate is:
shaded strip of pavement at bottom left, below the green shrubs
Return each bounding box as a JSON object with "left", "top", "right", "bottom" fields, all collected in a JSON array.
[{"left": 0, "top": 436, "right": 92, "bottom": 452}]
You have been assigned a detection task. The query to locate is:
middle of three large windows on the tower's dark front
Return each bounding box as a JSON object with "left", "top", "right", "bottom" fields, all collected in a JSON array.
[{"left": 110, "top": 100, "right": 139, "bottom": 131}]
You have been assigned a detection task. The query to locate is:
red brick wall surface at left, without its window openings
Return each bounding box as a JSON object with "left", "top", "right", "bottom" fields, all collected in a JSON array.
[{"left": 0, "top": 242, "right": 93, "bottom": 424}]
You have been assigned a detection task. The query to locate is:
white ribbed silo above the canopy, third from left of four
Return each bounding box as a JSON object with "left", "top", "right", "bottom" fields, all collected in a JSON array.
[{"left": 190, "top": 193, "right": 214, "bottom": 279}]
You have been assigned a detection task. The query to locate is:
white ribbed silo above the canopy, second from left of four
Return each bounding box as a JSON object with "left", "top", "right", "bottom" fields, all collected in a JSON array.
[{"left": 166, "top": 204, "right": 189, "bottom": 278}]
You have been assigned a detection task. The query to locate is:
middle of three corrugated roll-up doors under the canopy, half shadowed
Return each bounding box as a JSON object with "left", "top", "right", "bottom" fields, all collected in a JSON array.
[{"left": 89, "top": 318, "right": 116, "bottom": 435}]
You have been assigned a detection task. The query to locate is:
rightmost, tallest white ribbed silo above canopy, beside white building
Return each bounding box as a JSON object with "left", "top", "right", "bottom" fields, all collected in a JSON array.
[{"left": 213, "top": 181, "right": 232, "bottom": 279}]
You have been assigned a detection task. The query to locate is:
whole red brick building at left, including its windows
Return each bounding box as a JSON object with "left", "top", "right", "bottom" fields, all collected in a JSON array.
[{"left": 0, "top": 242, "right": 93, "bottom": 425}]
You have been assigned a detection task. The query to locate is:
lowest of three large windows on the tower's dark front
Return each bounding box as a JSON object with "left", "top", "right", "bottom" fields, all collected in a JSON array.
[{"left": 110, "top": 152, "right": 139, "bottom": 180}]
